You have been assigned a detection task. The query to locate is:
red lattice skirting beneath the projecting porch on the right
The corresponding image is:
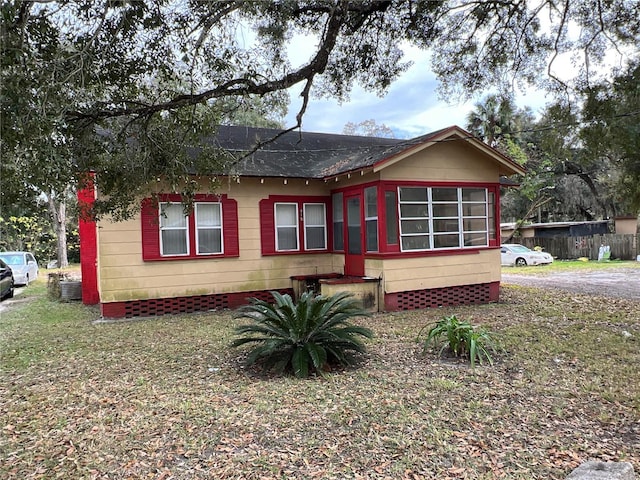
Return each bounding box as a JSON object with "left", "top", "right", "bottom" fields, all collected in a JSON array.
[{"left": 384, "top": 282, "right": 500, "bottom": 311}]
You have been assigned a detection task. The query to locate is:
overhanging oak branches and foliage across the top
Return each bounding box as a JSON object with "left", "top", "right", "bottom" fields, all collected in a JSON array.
[{"left": 0, "top": 0, "right": 640, "bottom": 219}]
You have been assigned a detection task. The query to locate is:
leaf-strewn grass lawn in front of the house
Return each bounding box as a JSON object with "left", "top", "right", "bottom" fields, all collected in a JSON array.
[{"left": 0, "top": 269, "right": 640, "bottom": 480}]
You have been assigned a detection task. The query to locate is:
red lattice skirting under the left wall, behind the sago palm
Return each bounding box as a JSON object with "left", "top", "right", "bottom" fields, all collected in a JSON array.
[{"left": 100, "top": 288, "right": 293, "bottom": 318}]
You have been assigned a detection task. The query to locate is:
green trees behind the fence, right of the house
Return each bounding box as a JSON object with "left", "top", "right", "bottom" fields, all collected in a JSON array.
[{"left": 467, "top": 56, "right": 640, "bottom": 225}]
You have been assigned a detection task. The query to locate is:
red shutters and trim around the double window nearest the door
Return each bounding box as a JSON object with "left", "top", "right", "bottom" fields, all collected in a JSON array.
[{"left": 259, "top": 195, "right": 333, "bottom": 255}]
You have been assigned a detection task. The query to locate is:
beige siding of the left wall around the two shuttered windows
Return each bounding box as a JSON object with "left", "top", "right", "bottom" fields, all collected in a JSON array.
[{"left": 98, "top": 179, "right": 343, "bottom": 302}]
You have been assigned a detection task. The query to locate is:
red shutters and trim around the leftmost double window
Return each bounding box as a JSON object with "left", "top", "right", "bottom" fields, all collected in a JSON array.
[{"left": 141, "top": 194, "right": 240, "bottom": 262}]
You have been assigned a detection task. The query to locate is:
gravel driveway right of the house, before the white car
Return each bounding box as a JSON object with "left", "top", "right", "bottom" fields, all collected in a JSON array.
[{"left": 502, "top": 267, "right": 640, "bottom": 300}]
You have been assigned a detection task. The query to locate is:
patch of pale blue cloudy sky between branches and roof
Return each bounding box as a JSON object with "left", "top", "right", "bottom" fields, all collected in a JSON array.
[{"left": 286, "top": 43, "right": 546, "bottom": 138}]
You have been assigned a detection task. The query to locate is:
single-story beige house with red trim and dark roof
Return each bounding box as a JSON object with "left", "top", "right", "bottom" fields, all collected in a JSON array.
[{"left": 79, "top": 126, "right": 524, "bottom": 317}]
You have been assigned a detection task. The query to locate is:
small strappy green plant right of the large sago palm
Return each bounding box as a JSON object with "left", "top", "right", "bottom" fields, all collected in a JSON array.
[{"left": 418, "top": 315, "right": 498, "bottom": 367}]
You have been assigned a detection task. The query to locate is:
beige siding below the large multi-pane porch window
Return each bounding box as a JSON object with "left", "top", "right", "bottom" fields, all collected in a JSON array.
[{"left": 384, "top": 249, "right": 500, "bottom": 293}]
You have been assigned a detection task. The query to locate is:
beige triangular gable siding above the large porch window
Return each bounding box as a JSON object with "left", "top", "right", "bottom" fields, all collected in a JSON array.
[{"left": 381, "top": 141, "right": 499, "bottom": 183}]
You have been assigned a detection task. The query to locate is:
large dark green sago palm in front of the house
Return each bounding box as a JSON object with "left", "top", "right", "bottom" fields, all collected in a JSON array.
[{"left": 232, "top": 292, "right": 373, "bottom": 377}]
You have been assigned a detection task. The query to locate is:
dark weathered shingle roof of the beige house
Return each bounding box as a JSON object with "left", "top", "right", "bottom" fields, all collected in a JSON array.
[{"left": 209, "top": 126, "right": 524, "bottom": 179}]
